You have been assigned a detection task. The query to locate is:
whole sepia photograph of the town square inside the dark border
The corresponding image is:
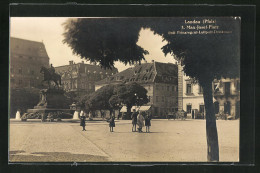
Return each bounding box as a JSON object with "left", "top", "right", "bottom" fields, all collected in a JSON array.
[{"left": 9, "top": 16, "right": 241, "bottom": 163}]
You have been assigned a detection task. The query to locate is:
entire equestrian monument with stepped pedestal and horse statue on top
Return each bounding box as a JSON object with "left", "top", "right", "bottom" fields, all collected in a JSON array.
[{"left": 22, "top": 66, "right": 73, "bottom": 120}]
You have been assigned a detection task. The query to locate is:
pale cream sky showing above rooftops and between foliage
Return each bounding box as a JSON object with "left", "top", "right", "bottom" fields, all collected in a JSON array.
[{"left": 10, "top": 17, "right": 175, "bottom": 72}]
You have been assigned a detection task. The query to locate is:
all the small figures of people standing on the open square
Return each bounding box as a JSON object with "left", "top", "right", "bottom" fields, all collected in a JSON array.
[{"left": 80, "top": 109, "right": 151, "bottom": 132}]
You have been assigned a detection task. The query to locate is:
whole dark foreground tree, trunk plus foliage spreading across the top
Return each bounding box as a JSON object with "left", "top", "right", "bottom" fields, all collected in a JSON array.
[{"left": 64, "top": 17, "right": 240, "bottom": 161}]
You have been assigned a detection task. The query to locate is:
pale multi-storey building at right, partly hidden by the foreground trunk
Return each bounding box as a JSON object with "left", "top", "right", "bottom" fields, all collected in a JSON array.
[{"left": 178, "top": 65, "right": 240, "bottom": 118}]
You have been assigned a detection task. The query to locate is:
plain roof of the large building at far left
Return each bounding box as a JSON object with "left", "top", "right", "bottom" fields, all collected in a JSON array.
[{"left": 10, "top": 37, "right": 49, "bottom": 58}]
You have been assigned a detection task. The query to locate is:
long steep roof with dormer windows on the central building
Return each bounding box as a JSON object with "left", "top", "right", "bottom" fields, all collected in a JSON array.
[{"left": 95, "top": 62, "right": 178, "bottom": 85}]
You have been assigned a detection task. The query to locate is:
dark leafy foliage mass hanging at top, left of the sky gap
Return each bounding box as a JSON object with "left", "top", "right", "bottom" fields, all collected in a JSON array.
[{"left": 63, "top": 18, "right": 148, "bottom": 68}]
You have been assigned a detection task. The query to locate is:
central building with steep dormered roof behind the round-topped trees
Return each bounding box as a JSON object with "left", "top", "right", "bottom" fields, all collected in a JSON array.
[{"left": 96, "top": 62, "right": 178, "bottom": 116}]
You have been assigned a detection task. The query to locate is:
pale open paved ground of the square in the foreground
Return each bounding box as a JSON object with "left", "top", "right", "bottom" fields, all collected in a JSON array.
[{"left": 9, "top": 120, "right": 239, "bottom": 162}]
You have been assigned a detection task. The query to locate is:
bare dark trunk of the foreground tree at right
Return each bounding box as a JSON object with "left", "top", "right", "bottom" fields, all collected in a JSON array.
[{"left": 201, "top": 81, "right": 219, "bottom": 162}]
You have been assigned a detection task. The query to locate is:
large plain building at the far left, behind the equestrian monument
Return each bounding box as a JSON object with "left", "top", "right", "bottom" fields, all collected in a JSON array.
[{"left": 10, "top": 37, "right": 49, "bottom": 88}]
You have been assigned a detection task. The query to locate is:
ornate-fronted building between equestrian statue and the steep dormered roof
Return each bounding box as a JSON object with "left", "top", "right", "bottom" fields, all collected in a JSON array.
[{"left": 55, "top": 61, "right": 118, "bottom": 95}]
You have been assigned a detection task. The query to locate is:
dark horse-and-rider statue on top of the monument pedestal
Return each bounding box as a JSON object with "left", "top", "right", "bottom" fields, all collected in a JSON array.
[{"left": 40, "top": 67, "right": 61, "bottom": 88}]
